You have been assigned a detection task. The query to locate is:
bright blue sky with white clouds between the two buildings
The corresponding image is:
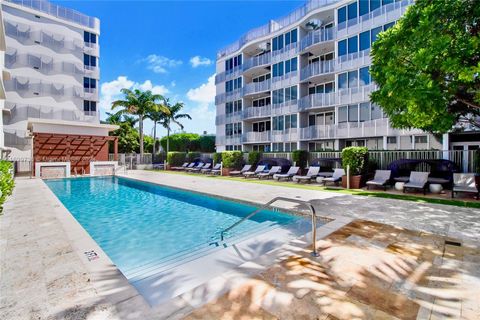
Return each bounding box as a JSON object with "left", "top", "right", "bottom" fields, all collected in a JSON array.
[{"left": 52, "top": 0, "right": 304, "bottom": 135}]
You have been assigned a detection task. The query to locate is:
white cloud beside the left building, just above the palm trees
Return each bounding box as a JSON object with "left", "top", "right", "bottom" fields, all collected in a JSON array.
[{"left": 100, "top": 76, "right": 169, "bottom": 111}]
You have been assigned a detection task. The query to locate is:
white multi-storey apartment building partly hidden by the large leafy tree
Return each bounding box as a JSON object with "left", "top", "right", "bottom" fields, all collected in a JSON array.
[{"left": 215, "top": 0, "right": 448, "bottom": 152}]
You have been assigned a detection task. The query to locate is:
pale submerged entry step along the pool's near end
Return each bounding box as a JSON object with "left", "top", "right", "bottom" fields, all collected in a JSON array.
[{"left": 123, "top": 222, "right": 288, "bottom": 283}]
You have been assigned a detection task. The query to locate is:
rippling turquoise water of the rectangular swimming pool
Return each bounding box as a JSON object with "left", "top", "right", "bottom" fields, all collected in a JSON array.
[{"left": 45, "top": 177, "right": 305, "bottom": 278}]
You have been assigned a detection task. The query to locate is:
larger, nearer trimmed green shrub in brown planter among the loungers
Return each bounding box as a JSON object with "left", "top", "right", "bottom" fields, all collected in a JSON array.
[{"left": 342, "top": 147, "right": 368, "bottom": 189}]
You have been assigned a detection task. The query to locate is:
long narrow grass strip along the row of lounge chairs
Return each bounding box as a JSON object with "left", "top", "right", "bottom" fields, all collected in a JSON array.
[{"left": 148, "top": 170, "right": 480, "bottom": 208}]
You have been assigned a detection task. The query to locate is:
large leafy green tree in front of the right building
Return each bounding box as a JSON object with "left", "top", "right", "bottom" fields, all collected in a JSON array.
[{"left": 370, "top": 0, "right": 480, "bottom": 133}]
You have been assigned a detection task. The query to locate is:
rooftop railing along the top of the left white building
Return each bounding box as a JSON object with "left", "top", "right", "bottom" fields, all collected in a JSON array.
[{"left": 7, "top": 0, "right": 100, "bottom": 29}]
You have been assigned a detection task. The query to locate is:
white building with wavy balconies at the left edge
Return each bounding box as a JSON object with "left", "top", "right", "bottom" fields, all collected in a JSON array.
[{"left": 0, "top": 0, "right": 100, "bottom": 158}]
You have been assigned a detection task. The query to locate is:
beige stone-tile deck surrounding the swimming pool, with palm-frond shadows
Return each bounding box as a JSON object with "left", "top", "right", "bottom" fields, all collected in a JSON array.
[{"left": 0, "top": 171, "right": 480, "bottom": 319}]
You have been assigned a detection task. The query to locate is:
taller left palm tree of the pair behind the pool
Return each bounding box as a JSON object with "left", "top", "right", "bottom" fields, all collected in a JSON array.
[{"left": 112, "top": 88, "right": 168, "bottom": 155}]
